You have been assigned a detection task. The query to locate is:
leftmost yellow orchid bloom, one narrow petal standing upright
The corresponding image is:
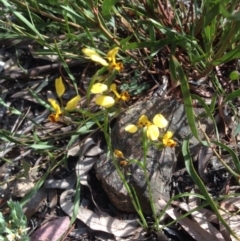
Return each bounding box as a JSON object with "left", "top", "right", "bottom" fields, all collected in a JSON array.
[{"left": 48, "top": 76, "right": 81, "bottom": 122}]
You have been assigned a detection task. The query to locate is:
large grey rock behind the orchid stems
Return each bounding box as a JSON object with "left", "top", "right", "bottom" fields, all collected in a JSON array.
[{"left": 95, "top": 98, "right": 211, "bottom": 214}]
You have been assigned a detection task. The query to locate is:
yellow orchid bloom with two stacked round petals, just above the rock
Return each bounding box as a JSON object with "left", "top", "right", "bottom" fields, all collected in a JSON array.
[{"left": 91, "top": 83, "right": 130, "bottom": 108}]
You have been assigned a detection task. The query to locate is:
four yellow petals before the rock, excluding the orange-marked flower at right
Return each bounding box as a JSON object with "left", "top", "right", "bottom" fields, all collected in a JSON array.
[{"left": 125, "top": 114, "right": 168, "bottom": 141}]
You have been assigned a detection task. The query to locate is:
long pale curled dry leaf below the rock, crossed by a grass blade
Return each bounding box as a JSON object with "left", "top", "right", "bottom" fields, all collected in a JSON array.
[{"left": 60, "top": 190, "right": 142, "bottom": 237}]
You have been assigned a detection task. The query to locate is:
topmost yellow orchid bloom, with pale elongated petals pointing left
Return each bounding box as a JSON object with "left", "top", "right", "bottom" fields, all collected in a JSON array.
[{"left": 82, "top": 47, "right": 123, "bottom": 71}]
